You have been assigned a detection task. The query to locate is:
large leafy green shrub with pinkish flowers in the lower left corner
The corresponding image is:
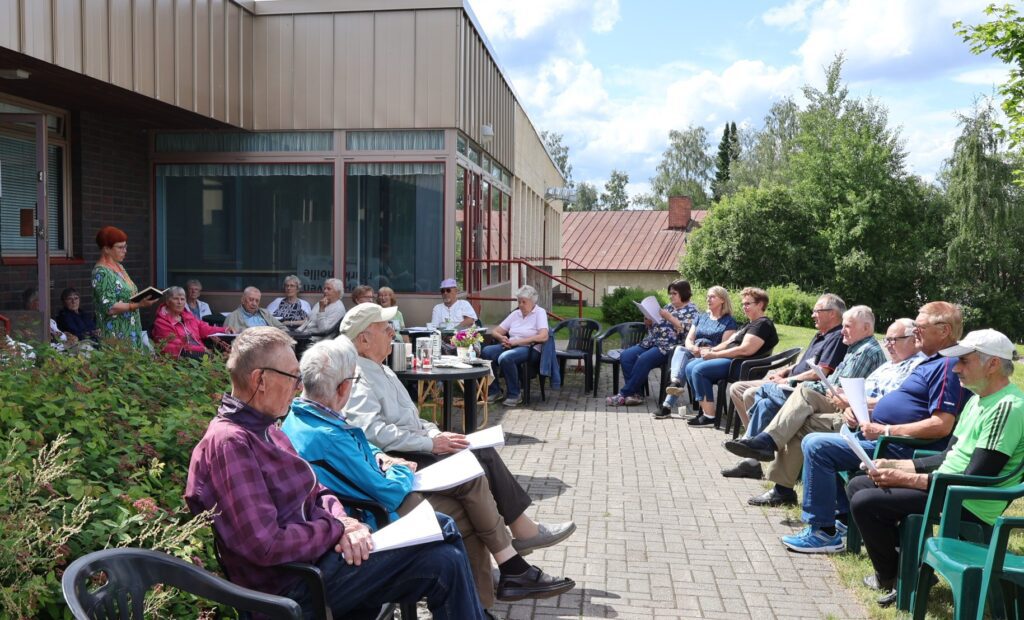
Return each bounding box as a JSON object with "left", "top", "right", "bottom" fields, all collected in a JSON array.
[{"left": 0, "top": 345, "right": 227, "bottom": 618}]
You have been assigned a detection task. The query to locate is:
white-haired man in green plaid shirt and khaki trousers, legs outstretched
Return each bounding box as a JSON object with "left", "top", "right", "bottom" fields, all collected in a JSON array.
[{"left": 722, "top": 305, "right": 897, "bottom": 483}]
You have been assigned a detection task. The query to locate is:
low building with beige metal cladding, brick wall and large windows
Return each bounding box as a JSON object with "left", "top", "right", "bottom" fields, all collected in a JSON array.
[{"left": 0, "top": 0, "right": 564, "bottom": 322}]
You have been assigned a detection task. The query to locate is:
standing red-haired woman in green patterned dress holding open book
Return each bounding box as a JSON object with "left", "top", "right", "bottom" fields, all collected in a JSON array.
[{"left": 92, "top": 226, "right": 158, "bottom": 348}]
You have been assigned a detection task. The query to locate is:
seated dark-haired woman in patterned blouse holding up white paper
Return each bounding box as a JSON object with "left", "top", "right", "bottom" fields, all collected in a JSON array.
[{"left": 605, "top": 280, "right": 698, "bottom": 407}]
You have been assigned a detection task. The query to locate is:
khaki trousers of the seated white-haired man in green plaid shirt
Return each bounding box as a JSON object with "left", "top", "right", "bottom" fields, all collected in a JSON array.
[{"left": 765, "top": 386, "right": 843, "bottom": 489}]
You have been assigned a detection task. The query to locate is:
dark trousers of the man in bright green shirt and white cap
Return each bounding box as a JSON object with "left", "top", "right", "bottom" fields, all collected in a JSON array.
[{"left": 846, "top": 476, "right": 981, "bottom": 583}]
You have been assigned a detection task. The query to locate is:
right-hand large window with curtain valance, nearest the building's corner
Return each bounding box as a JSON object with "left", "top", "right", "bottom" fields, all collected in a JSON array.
[{"left": 345, "top": 163, "right": 444, "bottom": 293}]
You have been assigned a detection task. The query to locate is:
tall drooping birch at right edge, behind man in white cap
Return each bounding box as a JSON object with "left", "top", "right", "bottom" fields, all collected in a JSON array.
[{"left": 940, "top": 102, "right": 1024, "bottom": 338}]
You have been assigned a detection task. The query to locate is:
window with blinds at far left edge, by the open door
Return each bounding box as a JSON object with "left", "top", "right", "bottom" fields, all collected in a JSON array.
[{"left": 0, "top": 100, "right": 70, "bottom": 256}]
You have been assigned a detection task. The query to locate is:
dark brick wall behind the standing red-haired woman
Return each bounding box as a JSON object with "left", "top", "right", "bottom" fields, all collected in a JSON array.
[{"left": 0, "top": 113, "right": 154, "bottom": 314}]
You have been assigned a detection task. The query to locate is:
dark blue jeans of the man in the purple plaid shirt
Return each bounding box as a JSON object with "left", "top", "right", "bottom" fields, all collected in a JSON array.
[{"left": 286, "top": 512, "right": 483, "bottom": 619}]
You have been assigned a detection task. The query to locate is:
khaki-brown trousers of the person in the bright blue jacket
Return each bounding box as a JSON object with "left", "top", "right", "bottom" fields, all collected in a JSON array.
[{"left": 397, "top": 476, "right": 512, "bottom": 609}]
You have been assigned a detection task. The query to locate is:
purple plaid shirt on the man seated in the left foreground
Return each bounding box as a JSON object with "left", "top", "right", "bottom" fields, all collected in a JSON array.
[{"left": 185, "top": 394, "right": 346, "bottom": 594}]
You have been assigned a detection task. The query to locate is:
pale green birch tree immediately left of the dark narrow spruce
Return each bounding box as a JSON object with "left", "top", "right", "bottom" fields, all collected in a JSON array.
[{"left": 644, "top": 127, "right": 715, "bottom": 210}]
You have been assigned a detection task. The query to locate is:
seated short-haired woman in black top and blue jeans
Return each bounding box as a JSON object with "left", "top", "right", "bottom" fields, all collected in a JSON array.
[{"left": 686, "top": 287, "right": 778, "bottom": 426}]
